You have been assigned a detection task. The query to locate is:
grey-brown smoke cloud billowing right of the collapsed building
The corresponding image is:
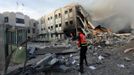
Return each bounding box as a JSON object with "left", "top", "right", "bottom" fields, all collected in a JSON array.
[{"left": 76, "top": 0, "right": 134, "bottom": 32}]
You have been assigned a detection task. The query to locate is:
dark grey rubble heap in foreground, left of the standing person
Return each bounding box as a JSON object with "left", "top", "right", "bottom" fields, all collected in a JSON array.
[{"left": 8, "top": 53, "right": 79, "bottom": 75}]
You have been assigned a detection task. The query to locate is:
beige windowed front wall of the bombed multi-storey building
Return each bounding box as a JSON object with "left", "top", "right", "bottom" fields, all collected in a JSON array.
[{"left": 40, "top": 4, "right": 79, "bottom": 40}]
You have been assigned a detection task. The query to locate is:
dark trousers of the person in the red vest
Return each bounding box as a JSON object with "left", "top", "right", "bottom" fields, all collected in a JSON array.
[{"left": 80, "top": 46, "right": 88, "bottom": 72}]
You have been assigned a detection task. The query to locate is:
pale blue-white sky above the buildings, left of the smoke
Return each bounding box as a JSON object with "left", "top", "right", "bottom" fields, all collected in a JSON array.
[{"left": 0, "top": 0, "right": 75, "bottom": 20}]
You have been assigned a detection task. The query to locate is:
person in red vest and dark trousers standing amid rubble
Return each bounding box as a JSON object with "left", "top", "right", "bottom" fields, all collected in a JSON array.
[{"left": 78, "top": 28, "right": 88, "bottom": 73}]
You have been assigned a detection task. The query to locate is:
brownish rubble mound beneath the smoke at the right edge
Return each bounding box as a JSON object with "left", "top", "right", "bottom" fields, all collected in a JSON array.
[{"left": 91, "top": 33, "right": 134, "bottom": 47}]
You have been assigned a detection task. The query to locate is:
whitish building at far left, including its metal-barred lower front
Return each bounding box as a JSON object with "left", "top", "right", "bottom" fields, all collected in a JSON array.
[{"left": 0, "top": 12, "right": 38, "bottom": 74}]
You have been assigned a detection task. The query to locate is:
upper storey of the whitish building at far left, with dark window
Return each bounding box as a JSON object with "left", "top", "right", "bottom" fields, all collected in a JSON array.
[{"left": 3, "top": 12, "right": 30, "bottom": 27}]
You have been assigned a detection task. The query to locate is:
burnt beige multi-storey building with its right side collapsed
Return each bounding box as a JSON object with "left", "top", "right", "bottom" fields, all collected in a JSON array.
[{"left": 39, "top": 4, "right": 94, "bottom": 39}]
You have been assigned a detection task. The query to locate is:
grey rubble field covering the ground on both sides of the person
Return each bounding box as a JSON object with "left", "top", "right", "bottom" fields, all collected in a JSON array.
[{"left": 9, "top": 34, "right": 134, "bottom": 75}]
